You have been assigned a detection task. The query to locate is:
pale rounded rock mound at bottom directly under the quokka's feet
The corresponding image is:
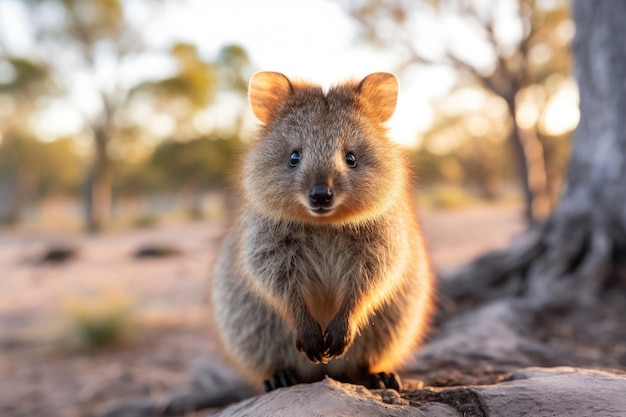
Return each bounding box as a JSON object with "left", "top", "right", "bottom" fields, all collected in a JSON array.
[{"left": 210, "top": 378, "right": 461, "bottom": 417}]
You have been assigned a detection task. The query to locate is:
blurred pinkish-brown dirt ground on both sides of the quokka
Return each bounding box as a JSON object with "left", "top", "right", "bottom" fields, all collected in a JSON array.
[{"left": 0, "top": 206, "right": 524, "bottom": 417}]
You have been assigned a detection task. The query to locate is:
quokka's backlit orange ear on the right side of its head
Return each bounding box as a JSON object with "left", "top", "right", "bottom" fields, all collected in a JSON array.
[{"left": 358, "top": 72, "right": 398, "bottom": 123}]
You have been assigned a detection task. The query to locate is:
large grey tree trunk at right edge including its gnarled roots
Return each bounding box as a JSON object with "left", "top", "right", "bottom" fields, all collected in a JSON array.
[{"left": 445, "top": 0, "right": 626, "bottom": 311}]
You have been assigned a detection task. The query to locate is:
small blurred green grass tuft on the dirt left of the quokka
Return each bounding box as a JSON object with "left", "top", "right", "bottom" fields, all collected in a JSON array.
[{"left": 63, "top": 290, "right": 134, "bottom": 348}]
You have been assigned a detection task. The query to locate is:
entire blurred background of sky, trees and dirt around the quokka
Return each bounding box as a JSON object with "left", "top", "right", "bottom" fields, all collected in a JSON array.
[{"left": 0, "top": 0, "right": 579, "bottom": 416}]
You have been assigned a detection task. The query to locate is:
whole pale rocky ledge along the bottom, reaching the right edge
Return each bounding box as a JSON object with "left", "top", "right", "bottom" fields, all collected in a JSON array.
[{"left": 214, "top": 367, "right": 626, "bottom": 417}]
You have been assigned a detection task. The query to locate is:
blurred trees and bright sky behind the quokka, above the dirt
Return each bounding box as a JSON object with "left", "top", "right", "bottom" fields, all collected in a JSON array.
[{"left": 0, "top": 0, "right": 578, "bottom": 231}]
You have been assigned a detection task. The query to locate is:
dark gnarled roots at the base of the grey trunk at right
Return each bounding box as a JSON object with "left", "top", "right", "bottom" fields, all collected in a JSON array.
[{"left": 442, "top": 207, "right": 626, "bottom": 311}]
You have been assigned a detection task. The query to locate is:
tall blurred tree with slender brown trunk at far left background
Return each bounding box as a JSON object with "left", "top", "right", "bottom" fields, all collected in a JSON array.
[{"left": 14, "top": 0, "right": 147, "bottom": 232}]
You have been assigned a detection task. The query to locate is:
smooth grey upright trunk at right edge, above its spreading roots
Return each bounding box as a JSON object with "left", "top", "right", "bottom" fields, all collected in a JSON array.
[{"left": 564, "top": 0, "right": 626, "bottom": 211}]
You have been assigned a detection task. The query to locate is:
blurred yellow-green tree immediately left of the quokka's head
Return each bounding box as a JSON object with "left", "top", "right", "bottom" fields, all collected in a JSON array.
[{"left": 131, "top": 43, "right": 250, "bottom": 217}]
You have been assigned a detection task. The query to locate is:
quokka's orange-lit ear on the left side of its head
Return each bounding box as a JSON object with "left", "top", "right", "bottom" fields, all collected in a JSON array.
[{"left": 248, "top": 71, "right": 293, "bottom": 123}]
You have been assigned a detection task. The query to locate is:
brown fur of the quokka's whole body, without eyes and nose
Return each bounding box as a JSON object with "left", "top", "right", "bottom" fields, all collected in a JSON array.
[{"left": 212, "top": 72, "right": 434, "bottom": 382}]
